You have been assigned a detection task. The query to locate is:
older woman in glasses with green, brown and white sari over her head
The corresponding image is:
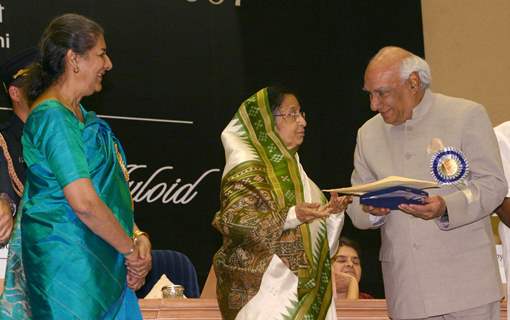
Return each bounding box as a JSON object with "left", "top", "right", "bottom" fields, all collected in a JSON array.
[{"left": 213, "top": 87, "right": 350, "bottom": 320}]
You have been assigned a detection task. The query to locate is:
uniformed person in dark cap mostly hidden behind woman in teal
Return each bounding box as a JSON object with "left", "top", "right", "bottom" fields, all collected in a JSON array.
[{"left": 0, "top": 47, "right": 38, "bottom": 244}]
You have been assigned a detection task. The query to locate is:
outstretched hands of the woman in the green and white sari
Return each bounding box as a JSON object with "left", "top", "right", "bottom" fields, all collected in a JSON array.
[{"left": 296, "top": 192, "right": 352, "bottom": 223}]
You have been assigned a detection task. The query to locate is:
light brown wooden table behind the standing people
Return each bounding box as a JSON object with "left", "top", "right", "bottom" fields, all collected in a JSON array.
[{"left": 140, "top": 299, "right": 507, "bottom": 320}]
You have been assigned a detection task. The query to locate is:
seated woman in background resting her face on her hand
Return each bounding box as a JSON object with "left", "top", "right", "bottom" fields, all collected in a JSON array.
[{"left": 331, "top": 237, "right": 373, "bottom": 300}]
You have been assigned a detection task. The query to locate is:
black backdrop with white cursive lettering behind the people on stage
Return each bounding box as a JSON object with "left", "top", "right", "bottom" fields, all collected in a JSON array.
[{"left": 0, "top": 0, "right": 423, "bottom": 297}]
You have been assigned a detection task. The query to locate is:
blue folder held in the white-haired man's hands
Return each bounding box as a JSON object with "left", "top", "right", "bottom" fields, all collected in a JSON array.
[{"left": 359, "top": 186, "right": 429, "bottom": 210}]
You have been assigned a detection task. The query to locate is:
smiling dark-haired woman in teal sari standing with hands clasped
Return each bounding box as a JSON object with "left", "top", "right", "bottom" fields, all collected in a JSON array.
[{"left": 1, "top": 14, "right": 150, "bottom": 319}]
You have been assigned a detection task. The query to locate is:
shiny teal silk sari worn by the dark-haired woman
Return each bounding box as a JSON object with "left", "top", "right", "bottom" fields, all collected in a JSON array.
[{"left": 0, "top": 100, "right": 141, "bottom": 319}]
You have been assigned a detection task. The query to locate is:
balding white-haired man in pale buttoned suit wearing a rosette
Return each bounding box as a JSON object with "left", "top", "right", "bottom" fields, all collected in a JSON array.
[{"left": 347, "top": 47, "right": 507, "bottom": 320}]
